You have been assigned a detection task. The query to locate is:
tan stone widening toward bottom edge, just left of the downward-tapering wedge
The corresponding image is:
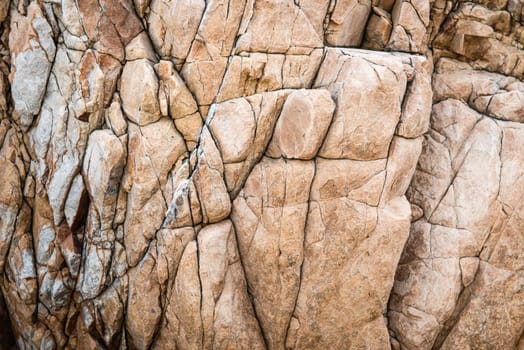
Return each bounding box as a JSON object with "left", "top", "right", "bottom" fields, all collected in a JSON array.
[{"left": 198, "top": 220, "right": 264, "bottom": 349}]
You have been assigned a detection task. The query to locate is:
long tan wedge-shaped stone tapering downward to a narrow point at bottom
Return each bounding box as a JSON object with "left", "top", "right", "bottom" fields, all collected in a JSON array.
[{"left": 231, "top": 158, "right": 314, "bottom": 349}]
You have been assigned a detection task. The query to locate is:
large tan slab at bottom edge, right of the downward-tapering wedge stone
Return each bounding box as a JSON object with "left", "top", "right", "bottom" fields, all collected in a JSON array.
[{"left": 288, "top": 197, "right": 410, "bottom": 348}]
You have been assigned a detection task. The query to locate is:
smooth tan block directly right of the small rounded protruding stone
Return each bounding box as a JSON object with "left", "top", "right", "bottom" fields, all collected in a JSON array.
[{"left": 315, "top": 49, "right": 407, "bottom": 160}]
